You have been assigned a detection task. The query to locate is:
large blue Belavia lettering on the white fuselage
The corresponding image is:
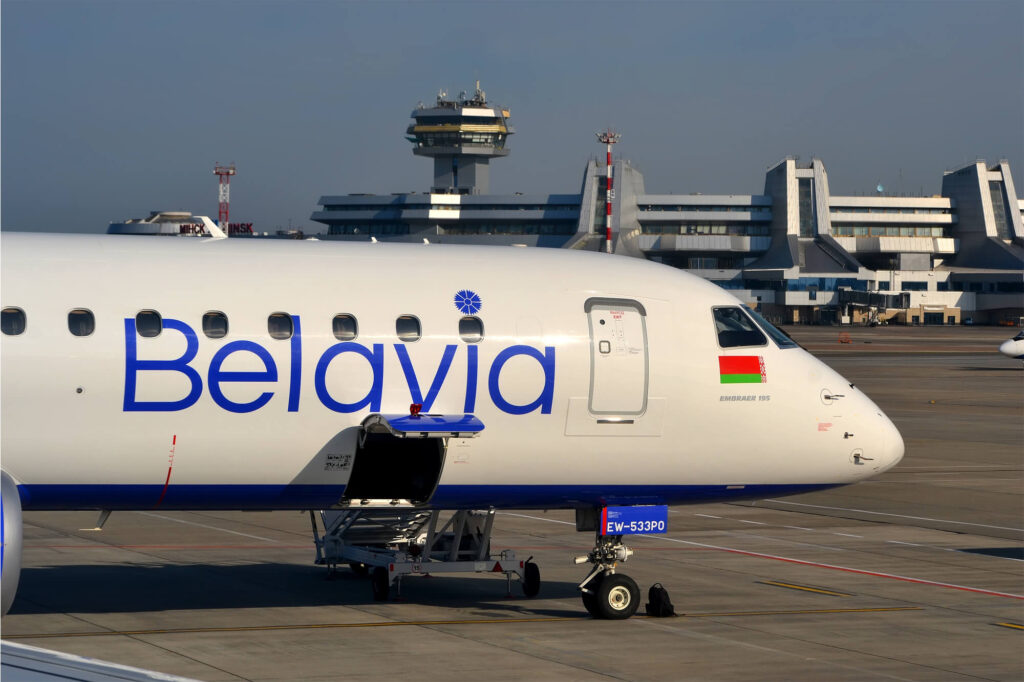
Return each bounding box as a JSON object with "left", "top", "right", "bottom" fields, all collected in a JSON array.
[{"left": 123, "top": 315, "right": 555, "bottom": 415}]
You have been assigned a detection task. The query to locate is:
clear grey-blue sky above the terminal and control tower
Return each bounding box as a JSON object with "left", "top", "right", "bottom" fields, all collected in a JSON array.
[{"left": 0, "top": 0, "right": 1024, "bottom": 232}]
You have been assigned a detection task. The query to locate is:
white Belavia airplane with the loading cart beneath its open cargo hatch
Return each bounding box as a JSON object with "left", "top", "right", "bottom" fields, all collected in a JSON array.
[{"left": 0, "top": 230, "right": 903, "bottom": 620}]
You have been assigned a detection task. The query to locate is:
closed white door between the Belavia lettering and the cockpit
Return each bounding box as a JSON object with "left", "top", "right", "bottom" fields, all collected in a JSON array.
[{"left": 585, "top": 298, "right": 649, "bottom": 415}]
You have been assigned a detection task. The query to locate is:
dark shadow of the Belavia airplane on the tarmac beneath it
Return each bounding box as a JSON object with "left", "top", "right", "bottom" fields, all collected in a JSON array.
[{"left": 10, "top": 563, "right": 585, "bottom": 617}]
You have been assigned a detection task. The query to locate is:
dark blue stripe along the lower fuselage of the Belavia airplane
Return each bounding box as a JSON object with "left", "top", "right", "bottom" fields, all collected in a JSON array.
[{"left": 18, "top": 483, "right": 841, "bottom": 511}]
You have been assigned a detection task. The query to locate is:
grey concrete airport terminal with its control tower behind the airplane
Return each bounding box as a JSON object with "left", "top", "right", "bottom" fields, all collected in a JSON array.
[{"left": 312, "top": 83, "right": 1024, "bottom": 324}]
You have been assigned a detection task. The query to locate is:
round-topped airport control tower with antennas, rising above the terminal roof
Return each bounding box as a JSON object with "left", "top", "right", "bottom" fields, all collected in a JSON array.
[{"left": 406, "top": 81, "right": 515, "bottom": 195}]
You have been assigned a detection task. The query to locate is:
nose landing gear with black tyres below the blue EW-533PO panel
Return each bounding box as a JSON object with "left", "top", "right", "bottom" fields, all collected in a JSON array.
[{"left": 575, "top": 532, "right": 640, "bottom": 621}]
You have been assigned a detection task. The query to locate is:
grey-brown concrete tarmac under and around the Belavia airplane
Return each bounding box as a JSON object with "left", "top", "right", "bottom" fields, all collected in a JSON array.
[{"left": 2, "top": 327, "right": 1024, "bottom": 682}]
